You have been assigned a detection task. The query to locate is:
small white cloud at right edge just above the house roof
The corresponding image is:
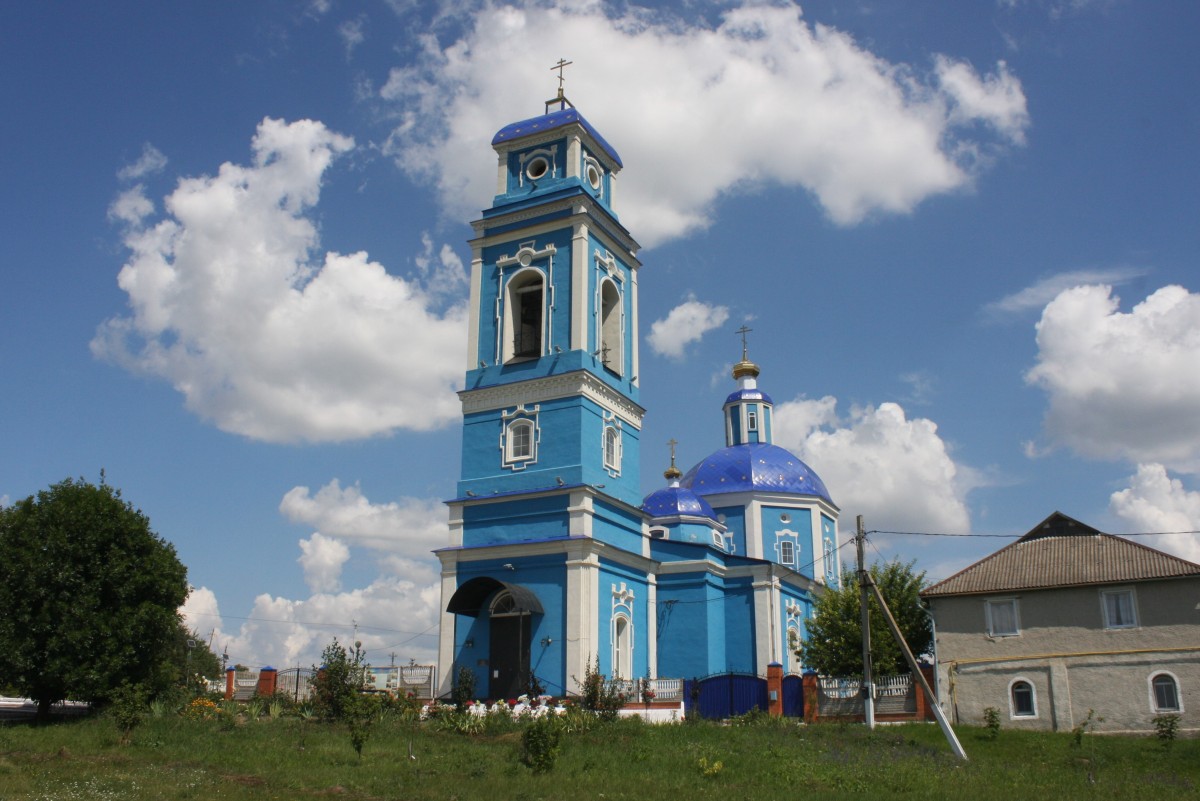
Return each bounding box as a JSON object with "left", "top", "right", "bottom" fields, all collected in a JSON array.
[{"left": 1109, "top": 464, "right": 1200, "bottom": 562}]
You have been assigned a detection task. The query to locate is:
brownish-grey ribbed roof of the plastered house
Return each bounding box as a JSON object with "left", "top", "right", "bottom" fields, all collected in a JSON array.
[{"left": 922, "top": 512, "right": 1200, "bottom": 597}]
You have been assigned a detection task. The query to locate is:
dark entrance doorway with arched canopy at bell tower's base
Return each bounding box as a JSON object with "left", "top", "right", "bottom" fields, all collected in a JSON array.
[{"left": 446, "top": 576, "right": 545, "bottom": 698}]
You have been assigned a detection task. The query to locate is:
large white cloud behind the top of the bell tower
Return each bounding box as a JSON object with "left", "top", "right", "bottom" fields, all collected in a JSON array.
[{"left": 379, "top": 2, "right": 1028, "bottom": 246}]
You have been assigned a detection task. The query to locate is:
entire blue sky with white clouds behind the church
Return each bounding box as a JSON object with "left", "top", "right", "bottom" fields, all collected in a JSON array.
[{"left": 0, "top": 0, "right": 1200, "bottom": 667}]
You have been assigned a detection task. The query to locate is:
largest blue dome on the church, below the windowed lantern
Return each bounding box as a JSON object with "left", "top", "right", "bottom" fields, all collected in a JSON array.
[{"left": 680, "top": 442, "right": 833, "bottom": 504}]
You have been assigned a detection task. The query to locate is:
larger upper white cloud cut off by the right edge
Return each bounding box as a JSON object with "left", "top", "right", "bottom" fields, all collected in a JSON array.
[{"left": 1025, "top": 285, "right": 1200, "bottom": 472}]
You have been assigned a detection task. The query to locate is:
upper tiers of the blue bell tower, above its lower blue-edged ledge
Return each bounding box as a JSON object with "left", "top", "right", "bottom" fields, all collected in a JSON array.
[{"left": 458, "top": 86, "right": 643, "bottom": 505}]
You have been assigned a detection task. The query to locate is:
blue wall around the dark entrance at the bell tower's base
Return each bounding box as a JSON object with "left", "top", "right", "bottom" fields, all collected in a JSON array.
[{"left": 454, "top": 554, "right": 566, "bottom": 697}]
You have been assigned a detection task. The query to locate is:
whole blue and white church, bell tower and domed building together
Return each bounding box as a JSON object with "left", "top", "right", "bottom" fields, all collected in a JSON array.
[{"left": 436, "top": 89, "right": 840, "bottom": 698}]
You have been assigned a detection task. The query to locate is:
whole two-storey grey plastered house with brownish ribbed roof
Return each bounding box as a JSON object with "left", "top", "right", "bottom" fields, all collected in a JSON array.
[{"left": 922, "top": 512, "right": 1200, "bottom": 731}]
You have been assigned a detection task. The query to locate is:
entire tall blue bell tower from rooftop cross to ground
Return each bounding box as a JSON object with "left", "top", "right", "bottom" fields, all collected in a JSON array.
[{"left": 437, "top": 74, "right": 655, "bottom": 698}]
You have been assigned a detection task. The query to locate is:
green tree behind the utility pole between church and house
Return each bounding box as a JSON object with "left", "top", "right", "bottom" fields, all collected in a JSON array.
[{"left": 797, "top": 560, "right": 934, "bottom": 676}]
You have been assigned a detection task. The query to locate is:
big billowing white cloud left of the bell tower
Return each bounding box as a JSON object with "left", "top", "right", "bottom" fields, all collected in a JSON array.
[{"left": 91, "top": 119, "right": 467, "bottom": 441}]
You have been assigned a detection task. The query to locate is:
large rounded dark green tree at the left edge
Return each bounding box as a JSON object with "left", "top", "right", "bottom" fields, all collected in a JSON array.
[{"left": 0, "top": 472, "right": 187, "bottom": 719}]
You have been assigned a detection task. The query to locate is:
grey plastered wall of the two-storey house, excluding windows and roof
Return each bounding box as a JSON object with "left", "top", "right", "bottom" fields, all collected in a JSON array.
[{"left": 929, "top": 578, "right": 1200, "bottom": 731}]
